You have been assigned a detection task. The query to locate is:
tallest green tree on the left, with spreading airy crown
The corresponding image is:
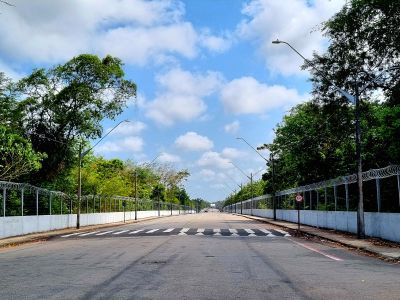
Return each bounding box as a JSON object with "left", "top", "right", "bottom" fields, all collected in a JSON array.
[{"left": 17, "top": 54, "right": 136, "bottom": 181}]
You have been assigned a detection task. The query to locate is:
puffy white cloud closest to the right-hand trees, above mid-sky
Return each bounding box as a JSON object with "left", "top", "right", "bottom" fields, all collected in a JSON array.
[{"left": 221, "top": 77, "right": 306, "bottom": 114}]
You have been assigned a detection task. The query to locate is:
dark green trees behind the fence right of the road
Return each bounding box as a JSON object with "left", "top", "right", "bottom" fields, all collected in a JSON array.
[{"left": 225, "top": 0, "right": 400, "bottom": 206}]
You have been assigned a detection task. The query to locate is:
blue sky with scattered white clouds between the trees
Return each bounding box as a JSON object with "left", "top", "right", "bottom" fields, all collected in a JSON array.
[{"left": 0, "top": 0, "right": 344, "bottom": 201}]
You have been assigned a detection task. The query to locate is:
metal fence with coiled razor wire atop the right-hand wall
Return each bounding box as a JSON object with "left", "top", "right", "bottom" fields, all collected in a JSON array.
[{"left": 225, "top": 165, "right": 400, "bottom": 212}]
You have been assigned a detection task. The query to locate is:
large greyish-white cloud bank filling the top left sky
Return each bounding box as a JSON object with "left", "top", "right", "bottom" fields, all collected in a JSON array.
[{"left": 0, "top": 0, "right": 199, "bottom": 65}]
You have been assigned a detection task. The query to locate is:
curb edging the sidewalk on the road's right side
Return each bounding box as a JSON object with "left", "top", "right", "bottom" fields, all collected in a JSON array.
[{"left": 234, "top": 214, "right": 400, "bottom": 262}]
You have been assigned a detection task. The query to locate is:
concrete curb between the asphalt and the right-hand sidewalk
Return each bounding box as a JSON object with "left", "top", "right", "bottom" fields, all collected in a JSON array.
[{"left": 235, "top": 214, "right": 400, "bottom": 261}]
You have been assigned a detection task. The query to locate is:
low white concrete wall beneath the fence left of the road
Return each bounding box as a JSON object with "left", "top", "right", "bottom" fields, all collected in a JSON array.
[{"left": 0, "top": 210, "right": 194, "bottom": 238}]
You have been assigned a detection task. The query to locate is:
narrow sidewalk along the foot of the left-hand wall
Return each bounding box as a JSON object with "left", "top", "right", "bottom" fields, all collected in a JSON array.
[{"left": 0, "top": 216, "right": 162, "bottom": 249}]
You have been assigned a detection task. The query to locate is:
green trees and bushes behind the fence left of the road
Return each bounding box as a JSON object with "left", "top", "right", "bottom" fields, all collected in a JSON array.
[{"left": 0, "top": 54, "right": 207, "bottom": 208}]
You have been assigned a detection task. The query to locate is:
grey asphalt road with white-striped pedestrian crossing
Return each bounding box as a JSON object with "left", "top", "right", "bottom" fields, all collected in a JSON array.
[{"left": 0, "top": 213, "right": 400, "bottom": 299}]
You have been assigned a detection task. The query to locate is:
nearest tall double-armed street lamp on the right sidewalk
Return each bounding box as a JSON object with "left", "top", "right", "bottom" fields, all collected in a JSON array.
[{"left": 272, "top": 39, "right": 398, "bottom": 239}]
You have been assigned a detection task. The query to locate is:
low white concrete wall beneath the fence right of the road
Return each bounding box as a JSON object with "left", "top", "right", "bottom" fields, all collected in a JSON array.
[{"left": 238, "top": 209, "right": 400, "bottom": 242}]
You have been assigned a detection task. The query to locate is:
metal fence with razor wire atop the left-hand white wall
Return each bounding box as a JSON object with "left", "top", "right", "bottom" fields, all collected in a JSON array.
[{"left": 0, "top": 181, "right": 192, "bottom": 217}]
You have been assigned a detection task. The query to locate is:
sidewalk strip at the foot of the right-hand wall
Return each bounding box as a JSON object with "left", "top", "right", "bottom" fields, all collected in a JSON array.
[{"left": 238, "top": 214, "right": 400, "bottom": 260}]
